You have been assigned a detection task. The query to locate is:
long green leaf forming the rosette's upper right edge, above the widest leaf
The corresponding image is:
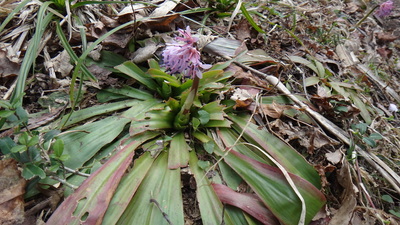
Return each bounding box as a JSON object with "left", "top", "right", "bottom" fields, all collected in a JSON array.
[{"left": 228, "top": 115, "right": 321, "bottom": 188}]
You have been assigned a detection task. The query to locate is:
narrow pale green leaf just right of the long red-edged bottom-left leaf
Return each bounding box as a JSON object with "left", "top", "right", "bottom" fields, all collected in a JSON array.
[{"left": 103, "top": 152, "right": 155, "bottom": 224}]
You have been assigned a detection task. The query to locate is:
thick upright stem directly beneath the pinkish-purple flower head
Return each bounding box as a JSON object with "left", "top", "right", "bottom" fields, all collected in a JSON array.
[{"left": 174, "top": 76, "right": 200, "bottom": 129}]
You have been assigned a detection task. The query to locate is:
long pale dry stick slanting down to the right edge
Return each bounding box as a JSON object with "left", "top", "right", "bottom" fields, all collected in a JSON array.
[{"left": 235, "top": 62, "right": 400, "bottom": 194}]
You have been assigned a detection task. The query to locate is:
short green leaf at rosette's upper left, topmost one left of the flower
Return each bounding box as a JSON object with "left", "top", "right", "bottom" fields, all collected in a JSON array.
[{"left": 115, "top": 61, "right": 159, "bottom": 91}]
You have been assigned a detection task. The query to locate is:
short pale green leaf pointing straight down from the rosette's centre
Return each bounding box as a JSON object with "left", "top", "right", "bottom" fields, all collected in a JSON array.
[{"left": 168, "top": 132, "right": 190, "bottom": 169}]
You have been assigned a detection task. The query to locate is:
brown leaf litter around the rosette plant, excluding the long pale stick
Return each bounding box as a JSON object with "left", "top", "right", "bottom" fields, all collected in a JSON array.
[{"left": 0, "top": 0, "right": 400, "bottom": 224}]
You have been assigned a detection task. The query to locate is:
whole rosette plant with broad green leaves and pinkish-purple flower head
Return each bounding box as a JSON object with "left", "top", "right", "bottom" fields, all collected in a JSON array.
[{"left": 47, "top": 26, "right": 325, "bottom": 225}]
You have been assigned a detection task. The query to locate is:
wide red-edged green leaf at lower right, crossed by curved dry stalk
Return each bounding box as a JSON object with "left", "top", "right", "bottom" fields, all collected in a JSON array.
[{"left": 220, "top": 150, "right": 326, "bottom": 225}]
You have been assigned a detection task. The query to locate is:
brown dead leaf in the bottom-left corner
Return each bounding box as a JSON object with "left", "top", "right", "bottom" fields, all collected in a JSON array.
[{"left": 0, "top": 159, "right": 26, "bottom": 225}]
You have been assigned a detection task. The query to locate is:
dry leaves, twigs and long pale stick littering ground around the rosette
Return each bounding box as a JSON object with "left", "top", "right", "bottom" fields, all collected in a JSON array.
[{"left": 0, "top": 0, "right": 400, "bottom": 225}]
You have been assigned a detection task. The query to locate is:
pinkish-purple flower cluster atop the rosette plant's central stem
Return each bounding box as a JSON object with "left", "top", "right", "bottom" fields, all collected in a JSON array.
[{"left": 162, "top": 26, "right": 211, "bottom": 78}]
